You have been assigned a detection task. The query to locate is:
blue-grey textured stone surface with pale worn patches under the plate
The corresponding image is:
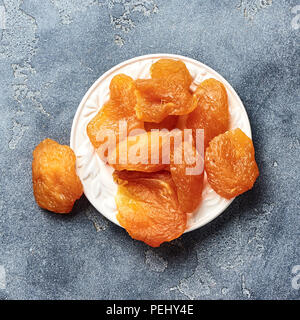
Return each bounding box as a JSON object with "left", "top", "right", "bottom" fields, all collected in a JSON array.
[{"left": 0, "top": 0, "right": 300, "bottom": 299}]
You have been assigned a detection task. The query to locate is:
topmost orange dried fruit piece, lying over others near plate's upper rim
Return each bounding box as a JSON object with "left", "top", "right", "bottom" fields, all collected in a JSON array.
[{"left": 136, "top": 59, "right": 195, "bottom": 123}]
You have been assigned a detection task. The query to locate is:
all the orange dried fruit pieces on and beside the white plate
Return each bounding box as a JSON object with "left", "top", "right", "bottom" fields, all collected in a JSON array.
[{"left": 33, "top": 59, "right": 259, "bottom": 247}]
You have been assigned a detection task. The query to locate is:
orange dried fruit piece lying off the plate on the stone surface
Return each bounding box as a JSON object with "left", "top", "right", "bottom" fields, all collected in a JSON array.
[{"left": 32, "top": 139, "right": 83, "bottom": 213}]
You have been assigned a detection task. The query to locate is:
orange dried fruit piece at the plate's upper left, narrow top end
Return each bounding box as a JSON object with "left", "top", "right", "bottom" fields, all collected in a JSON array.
[{"left": 87, "top": 74, "right": 144, "bottom": 161}]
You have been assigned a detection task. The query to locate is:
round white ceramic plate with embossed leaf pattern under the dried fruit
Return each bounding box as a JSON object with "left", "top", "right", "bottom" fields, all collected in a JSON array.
[{"left": 70, "top": 54, "right": 251, "bottom": 232}]
